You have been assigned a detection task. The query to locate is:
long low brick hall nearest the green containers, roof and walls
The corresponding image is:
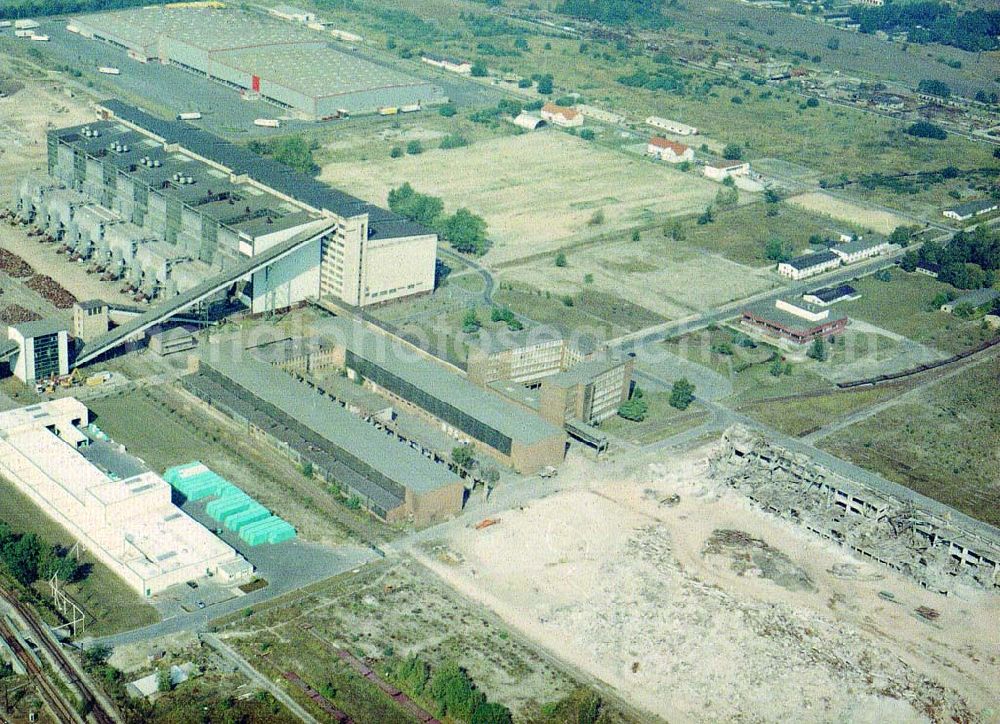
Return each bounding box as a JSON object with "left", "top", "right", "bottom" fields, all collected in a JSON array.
[{"left": 184, "top": 346, "right": 465, "bottom": 524}]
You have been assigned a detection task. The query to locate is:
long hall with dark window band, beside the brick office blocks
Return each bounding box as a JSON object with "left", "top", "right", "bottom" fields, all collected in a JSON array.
[{"left": 324, "top": 317, "right": 566, "bottom": 474}]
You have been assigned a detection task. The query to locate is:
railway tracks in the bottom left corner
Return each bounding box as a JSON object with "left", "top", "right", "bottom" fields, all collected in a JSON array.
[{"left": 0, "top": 588, "right": 121, "bottom": 724}]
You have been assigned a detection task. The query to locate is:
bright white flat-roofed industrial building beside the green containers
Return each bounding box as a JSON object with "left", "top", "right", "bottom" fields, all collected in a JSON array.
[{"left": 0, "top": 397, "right": 253, "bottom": 597}]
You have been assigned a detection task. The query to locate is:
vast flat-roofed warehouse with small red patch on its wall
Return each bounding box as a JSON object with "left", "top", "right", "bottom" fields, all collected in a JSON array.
[{"left": 68, "top": 7, "right": 445, "bottom": 120}]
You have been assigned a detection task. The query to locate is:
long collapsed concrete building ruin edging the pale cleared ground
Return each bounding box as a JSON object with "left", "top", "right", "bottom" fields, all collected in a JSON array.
[{"left": 709, "top": 426, "right": 1000, "bottom": 593}]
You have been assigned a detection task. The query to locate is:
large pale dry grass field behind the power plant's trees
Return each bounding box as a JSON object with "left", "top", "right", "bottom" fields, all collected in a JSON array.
[{"left": 320, "top": 130, "right": 718, "bottom": 263}]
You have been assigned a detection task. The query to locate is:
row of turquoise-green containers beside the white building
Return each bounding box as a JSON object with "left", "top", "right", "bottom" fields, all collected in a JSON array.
[{"left": 163, "top": 461, "right": 295, "bottom": 546}]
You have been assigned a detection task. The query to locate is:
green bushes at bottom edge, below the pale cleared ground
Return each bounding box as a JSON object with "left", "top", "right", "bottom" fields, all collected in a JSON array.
[{"left": 394, "top": 655, "right": 513, "bottom": 724}]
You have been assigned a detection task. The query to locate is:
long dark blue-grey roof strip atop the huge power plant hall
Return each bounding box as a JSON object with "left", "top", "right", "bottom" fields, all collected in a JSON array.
[{"left": 101, "top": 99, "right": 434, "bottom": 239}]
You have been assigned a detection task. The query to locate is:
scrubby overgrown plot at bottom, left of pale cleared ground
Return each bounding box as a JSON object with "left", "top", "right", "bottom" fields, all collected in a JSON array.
[{"left": 220, "top": 560, "right": 640, "bottom": 724}]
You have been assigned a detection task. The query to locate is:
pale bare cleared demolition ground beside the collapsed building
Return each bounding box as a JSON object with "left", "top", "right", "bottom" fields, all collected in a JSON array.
[{"left": 412, "top": 449, "right": 1000, "bottom": 722}]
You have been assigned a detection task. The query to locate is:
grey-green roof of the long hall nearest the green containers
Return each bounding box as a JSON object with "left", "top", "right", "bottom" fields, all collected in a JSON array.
[{"left": 202, "top": 346, "right": 462, "bottom": 492}]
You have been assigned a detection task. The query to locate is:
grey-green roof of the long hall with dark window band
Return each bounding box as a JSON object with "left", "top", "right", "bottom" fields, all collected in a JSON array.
[{"left": 330, "top": 317, "right": 563, "bottom": 445}]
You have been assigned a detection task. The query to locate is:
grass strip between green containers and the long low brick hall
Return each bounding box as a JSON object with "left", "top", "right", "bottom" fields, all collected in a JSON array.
[{"left": 88, "top": 387, "right": 382, "bottom": 545}]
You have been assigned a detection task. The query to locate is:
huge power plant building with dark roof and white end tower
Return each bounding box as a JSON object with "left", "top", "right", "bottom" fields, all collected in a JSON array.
[{"left": 18, "top": 101, "right": 437, "bottom": 312}]
